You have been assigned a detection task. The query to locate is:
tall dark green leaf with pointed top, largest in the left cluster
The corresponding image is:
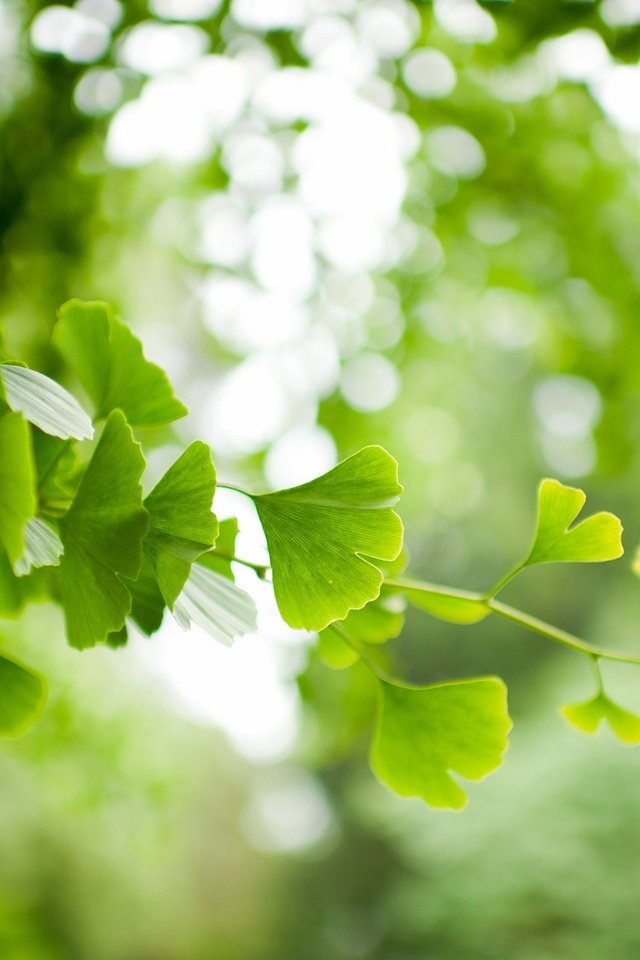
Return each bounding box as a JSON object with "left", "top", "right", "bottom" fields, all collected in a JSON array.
[{"left": 60, "top": 410, "right": 149, "bottom": 649}]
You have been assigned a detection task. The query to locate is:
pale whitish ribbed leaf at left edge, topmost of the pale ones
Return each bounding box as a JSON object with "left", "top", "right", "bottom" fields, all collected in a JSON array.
[{"left": 0, "top": 363, "right": 93, "bottom": 440}]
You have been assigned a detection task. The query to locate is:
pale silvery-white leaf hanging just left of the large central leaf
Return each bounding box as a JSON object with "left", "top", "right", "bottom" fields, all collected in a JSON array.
[{"left": 173, "top": 563, "right": 257, "bottom": 646}]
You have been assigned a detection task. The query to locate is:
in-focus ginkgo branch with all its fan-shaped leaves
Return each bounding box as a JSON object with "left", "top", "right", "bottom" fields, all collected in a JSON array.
[{"left": 0, "top": 301, "right": 640, "bottom": 809}]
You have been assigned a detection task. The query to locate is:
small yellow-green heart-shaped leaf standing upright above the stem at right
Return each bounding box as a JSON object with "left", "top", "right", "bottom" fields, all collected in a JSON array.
[{"left": 523, "top": 480, "right": 624, "bottom": 566}]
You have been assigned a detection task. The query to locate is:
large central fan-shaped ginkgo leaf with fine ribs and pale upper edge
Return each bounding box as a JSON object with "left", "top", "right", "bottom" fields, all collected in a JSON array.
[{"left": 254, "top": 446, "right": 402, "bottom": 630}]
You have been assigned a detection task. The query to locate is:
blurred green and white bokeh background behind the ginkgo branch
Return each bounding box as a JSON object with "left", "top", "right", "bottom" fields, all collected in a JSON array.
[{"left": 0, "top": 0, "right": 640, "bottom": 960}]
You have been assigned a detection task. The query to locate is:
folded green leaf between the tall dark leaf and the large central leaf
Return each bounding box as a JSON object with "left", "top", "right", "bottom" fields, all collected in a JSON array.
[{"left": 144, "top": 440, "right": 218, "bottom": 609}]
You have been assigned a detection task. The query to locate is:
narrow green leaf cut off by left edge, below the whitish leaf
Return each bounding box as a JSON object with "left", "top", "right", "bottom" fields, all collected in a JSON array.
[{"left": 0, "top": 413, "right": 37, "bottom": 565}]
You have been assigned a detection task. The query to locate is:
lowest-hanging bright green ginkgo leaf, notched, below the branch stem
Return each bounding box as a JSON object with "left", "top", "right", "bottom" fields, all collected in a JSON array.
[{"left": 371, "top": 677, "right": 511, "bottom": 810}]
